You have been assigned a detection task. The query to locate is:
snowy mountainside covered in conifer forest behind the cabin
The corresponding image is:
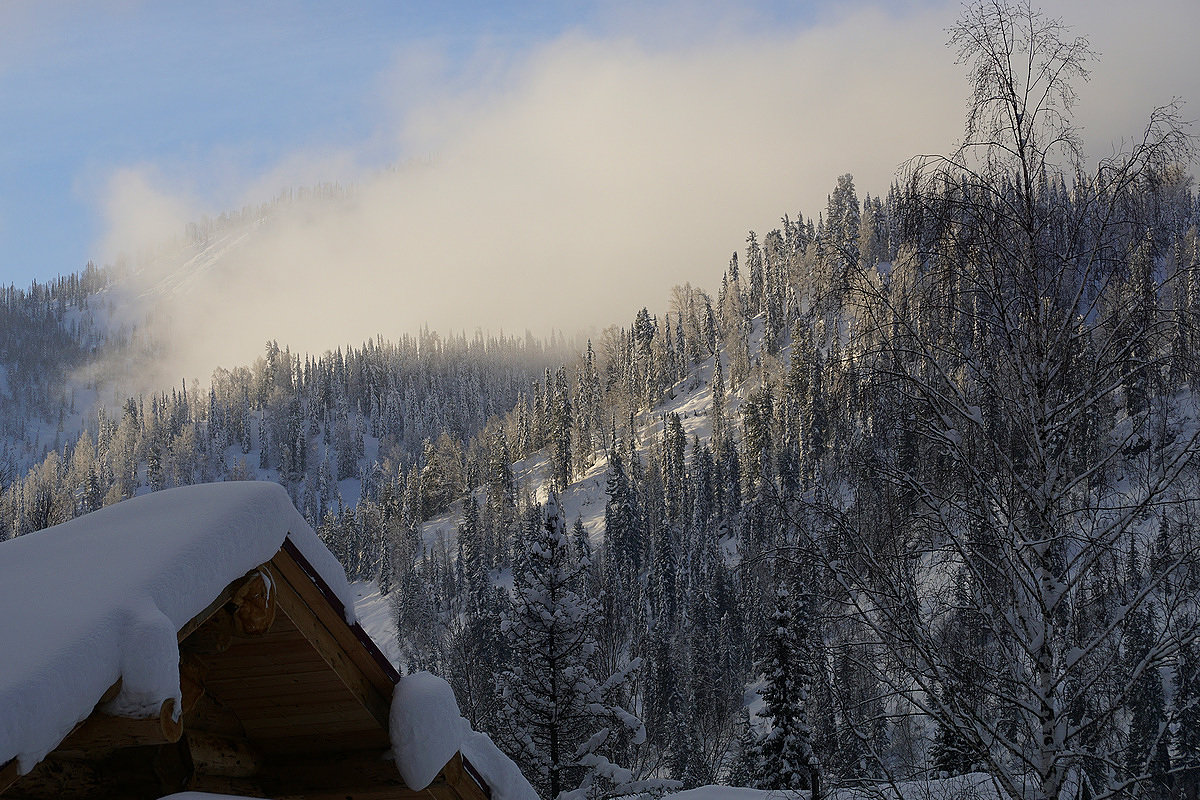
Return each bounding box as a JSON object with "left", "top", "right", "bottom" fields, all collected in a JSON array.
[{"left": 0, "top": 4, "right": 1200, "bottom": 799}]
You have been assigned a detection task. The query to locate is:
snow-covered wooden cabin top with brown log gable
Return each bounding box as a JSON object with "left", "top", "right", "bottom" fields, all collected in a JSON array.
[{"left": 0, "top": 482, "right": 534, "bottom": 800}]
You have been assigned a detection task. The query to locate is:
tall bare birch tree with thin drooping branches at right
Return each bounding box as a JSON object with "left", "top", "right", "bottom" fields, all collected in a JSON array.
[{"left": 814, "top": 0, "right": 1198, "bottom": 800}]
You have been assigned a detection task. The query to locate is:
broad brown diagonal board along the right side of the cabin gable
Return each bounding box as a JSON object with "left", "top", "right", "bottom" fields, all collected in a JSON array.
[{"left": 272, "top": 555, "right": 392, "bottom": 730}]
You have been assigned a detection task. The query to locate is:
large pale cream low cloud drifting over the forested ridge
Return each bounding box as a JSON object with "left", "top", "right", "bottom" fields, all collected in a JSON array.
[{"left": 96, "top": 4, "right": 1200, "bottom": 388}]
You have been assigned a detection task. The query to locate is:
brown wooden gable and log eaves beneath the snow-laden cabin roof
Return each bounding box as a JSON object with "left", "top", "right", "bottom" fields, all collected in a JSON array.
[{"left": 0, "top": 540, "right": 490, "bottom": 800}]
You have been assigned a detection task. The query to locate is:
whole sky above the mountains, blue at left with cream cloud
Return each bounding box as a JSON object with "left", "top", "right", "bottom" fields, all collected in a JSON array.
[{"left": 0, "top": 0, "right": 1200, "bottom": 374}]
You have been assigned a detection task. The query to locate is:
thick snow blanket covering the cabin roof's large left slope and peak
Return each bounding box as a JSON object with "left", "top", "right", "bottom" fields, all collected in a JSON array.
[{"left": 0, "top": 481, "right": 354, "bottom": 772}]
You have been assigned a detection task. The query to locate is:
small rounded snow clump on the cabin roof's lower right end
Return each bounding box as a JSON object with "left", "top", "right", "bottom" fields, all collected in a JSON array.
[{"left": 391, "top": 672, "right": 538, "bottom": 800}]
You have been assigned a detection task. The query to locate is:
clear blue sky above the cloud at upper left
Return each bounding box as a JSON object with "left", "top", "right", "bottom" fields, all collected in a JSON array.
[{"left": 0, "top": 0, "right": 812, "bottom": 285}]
